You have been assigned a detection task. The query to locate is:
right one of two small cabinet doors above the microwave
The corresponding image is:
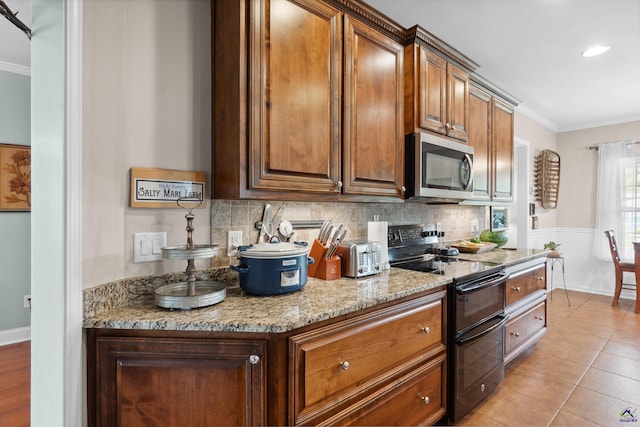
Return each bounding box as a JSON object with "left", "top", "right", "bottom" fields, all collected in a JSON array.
[{"left": 446, "top": 64, "right": 469, "bottom": 141}]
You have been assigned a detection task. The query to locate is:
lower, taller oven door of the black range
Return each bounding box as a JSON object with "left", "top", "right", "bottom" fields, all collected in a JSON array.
[{"left": 451, "top": 315, "right": 506, "bottom": 422}]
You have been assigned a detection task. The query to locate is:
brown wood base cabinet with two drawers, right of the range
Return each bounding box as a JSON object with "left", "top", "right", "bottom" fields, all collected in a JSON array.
[{"left": 504, "top": 258, "right": 547, "bottom": 364}]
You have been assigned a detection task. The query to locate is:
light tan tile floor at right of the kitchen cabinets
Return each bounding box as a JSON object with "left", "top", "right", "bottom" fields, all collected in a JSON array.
[{"left": 459, "top": 289, "right": 640, "bottom": 427}]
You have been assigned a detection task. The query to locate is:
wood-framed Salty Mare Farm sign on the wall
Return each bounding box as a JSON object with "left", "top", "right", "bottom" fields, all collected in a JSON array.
[{"left": 131, "top": 167, "right": 206, "bottom": 208}]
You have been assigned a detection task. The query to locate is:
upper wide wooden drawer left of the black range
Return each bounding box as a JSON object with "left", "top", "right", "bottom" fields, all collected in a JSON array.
[{"left": 290, "top": 295, "right": 445, "bottom": 424}]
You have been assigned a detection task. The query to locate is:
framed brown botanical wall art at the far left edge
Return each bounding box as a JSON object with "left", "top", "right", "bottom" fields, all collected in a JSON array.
[{"left": 0, "top": 144, "right": 31, "bottom": 211}]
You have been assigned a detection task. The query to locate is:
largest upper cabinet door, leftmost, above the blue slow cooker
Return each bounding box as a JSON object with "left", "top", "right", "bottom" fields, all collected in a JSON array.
[{"left": 248, "top": 0, "right": 342, "bottom": 193}]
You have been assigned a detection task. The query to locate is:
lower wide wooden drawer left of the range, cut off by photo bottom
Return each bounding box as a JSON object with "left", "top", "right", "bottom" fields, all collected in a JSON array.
[{"left": 322, "top": 354, "right": 446, "bottom": 426}]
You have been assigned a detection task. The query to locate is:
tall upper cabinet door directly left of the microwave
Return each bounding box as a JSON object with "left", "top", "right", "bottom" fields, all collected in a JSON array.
[{"left": 343, "top": 17, "right": 404, "bottom": 196}]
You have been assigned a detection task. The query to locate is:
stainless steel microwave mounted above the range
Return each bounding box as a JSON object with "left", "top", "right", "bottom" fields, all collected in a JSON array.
[{"left": 405, "top": 133, "right": 473, "bottom": 203}]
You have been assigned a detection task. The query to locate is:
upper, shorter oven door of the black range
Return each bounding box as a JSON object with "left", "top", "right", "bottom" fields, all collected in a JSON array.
[{"left": 454, "top": 271, "right": 509, "bottom": 333}]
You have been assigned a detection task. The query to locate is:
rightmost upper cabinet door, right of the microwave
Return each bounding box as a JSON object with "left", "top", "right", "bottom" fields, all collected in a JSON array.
[{"left": 491, "top": 98, "right": 514, "bottom": 202}]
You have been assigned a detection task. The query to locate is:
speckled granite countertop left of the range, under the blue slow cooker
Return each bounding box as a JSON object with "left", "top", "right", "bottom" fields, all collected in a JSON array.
[{"left": 83, "top": 268, "right": 451, "bottom": 333}]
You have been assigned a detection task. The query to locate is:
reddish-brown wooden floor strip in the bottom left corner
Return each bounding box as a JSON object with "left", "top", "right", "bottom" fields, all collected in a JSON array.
[{"left": 0, "top": 341, "right": 31, "bottom": 427}]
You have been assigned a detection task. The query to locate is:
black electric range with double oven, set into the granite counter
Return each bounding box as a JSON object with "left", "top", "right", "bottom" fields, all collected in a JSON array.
[{"left": 387, "top": 225, "right": 508, "bottom": 425}]
